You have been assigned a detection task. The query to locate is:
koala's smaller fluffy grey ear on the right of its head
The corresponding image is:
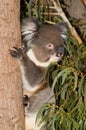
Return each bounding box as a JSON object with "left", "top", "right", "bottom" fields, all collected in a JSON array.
[{"left": 55, "top": 22, "right": 68, "bottom": 39}]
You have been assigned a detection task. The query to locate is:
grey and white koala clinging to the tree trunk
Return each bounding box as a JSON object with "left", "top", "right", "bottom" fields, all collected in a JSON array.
[{"left": 10, "top": 18, "right": 67, "bottom": 130}]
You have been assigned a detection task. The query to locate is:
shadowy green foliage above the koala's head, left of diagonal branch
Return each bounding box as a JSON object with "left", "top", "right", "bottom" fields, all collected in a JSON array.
[{"left": 21, "top": 0, "right": 62, "bottom": 23}]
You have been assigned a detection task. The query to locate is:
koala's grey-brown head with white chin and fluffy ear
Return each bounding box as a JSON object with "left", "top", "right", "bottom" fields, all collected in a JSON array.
[{"left": 22, "top": 19, "right": 66, "bottom": 67}]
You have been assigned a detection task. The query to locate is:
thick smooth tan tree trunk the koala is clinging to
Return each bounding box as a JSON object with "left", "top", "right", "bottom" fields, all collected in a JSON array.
[{"left": 0, "top": 0, "right": 24, "bottom": 130}]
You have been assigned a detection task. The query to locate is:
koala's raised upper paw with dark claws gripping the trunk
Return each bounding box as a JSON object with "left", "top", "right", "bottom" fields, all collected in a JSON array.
[{"left": 9, "top": 47, "right": 23, "bottom": 58}]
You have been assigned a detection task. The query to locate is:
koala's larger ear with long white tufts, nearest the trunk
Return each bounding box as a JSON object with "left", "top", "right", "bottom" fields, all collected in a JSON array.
[{"left": 21, "top": 18, "right": 41, "bottom": 49}]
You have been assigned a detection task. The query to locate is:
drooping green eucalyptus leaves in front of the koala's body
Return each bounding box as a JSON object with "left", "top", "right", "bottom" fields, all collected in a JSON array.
[{"left": 38, "top": 36, "right": 86, "bottom": 130}]
